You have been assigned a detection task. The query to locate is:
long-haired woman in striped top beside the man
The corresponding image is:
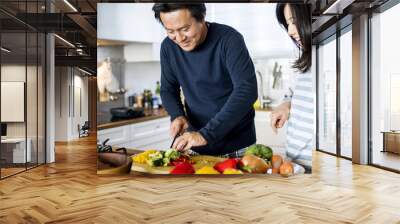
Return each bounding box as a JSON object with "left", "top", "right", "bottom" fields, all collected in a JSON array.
[{"left": 271, "top": 3, "right": 314, "bottom": 173}]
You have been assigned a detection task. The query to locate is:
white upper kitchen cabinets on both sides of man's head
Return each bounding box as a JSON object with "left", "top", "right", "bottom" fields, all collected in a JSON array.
[{"left": 97, "top": 3, "right": 295, "bottom": 58}]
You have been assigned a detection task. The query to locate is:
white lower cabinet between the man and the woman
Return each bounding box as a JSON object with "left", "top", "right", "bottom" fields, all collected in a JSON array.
[{"left": 254, "top": 111, "right": 286, "bottom": 147}]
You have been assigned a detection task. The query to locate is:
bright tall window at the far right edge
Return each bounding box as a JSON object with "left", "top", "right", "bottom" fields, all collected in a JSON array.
[{"left": 370, "top": 1, "right": 400, "bottom": 171}]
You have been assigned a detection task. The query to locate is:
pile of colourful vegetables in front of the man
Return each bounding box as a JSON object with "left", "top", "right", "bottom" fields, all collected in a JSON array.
[{"left": 132, "top": 144, "right": 294, "bottom": 177}]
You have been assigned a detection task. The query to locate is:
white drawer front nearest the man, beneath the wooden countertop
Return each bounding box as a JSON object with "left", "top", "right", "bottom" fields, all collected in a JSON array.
[{"left": 130, "top": 118, "right": 170, "bottom": 140}]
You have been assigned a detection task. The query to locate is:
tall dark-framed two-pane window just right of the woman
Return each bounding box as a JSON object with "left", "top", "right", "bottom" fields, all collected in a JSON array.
[{"left": 317, "top": 20, "right": 353, "bottom": 160}]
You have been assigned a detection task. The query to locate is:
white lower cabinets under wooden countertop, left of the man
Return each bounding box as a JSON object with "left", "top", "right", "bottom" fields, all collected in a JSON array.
[{"left": 97, "top": 117, "right": 172, "bottom": 150}]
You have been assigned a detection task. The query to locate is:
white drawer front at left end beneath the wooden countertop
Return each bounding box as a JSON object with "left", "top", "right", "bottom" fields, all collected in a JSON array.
[{"left": 97, "top": 125, "right": 130, "bottom": 145}]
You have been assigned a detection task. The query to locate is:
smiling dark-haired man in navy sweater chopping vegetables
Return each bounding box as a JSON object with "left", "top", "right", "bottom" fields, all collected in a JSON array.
[{"left": 153, "top": 3, "right": 257, "bottom": 156}]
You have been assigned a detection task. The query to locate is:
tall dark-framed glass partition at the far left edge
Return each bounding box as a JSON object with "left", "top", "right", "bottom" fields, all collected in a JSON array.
[{"left": 0, "top": 1, "right": 46, "bottom": 179}]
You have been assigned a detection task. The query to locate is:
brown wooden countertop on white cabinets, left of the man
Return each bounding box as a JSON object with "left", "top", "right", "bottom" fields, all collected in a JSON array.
[{"left": 97, "top": 109, "right": 168, "bottom": 130}]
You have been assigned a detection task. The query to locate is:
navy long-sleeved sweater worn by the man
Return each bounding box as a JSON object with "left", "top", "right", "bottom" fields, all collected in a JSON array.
[{"left": 160, "top": 23, "right": 257, "bottom": 155}]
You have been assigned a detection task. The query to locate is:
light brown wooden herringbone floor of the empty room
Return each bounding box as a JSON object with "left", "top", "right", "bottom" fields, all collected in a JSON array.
[{"left": 0, "top": 134, "right": 400, "bottom": 224}]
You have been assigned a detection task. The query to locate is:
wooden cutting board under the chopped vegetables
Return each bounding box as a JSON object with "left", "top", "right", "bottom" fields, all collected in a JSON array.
[{"left": 131, "top": 156, "right": 226, "bottom": 174}]
